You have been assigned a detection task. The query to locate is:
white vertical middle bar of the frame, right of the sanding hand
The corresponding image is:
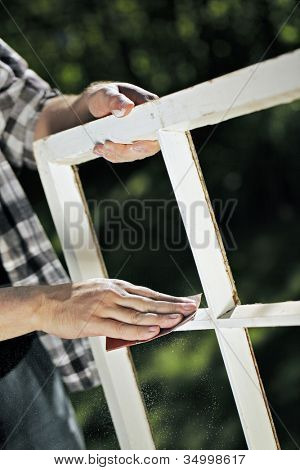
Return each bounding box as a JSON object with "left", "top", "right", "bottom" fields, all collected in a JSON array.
[{"left": 158, "top": 130, "right": 279, "bottom": 449}]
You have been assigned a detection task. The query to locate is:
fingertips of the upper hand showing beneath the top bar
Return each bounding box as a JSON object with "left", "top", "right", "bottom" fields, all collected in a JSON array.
[{"left": 93, "top": 140, "right": 160, "bottom": 163}]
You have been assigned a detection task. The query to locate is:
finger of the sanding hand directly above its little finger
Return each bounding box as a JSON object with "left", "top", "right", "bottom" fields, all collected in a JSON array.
[{"left": 101, "top": 306, "right": 183, "bottom": 328}]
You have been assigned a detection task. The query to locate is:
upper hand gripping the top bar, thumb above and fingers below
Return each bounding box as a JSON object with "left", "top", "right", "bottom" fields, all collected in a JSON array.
[{"left": 34, "top": 82, "right": 159, "bottom": 163}]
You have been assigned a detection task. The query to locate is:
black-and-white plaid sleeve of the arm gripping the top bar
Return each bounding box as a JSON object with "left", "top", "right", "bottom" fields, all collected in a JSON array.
[{"left": 0, "top": 39, "right": 58, "bottom": 168}]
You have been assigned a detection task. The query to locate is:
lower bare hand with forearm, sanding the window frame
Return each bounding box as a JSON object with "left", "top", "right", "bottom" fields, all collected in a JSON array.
[{"left": 0, "top": 279, "right": 197, "bottom": 341}]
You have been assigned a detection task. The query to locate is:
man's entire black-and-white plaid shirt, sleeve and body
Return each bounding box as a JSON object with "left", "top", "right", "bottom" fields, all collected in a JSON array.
[{"left": 0, "top": 39, "right": 100, "bottom": 391}]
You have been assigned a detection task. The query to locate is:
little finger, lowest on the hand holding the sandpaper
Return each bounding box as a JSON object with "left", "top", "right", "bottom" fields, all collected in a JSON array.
[{"left": 85, "top": 317, "right": 160, "bottom": 341}]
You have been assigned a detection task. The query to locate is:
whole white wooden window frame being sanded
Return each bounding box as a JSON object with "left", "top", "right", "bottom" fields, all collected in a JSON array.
[{"left": 34, "top": 49, "right": 300, "bottom": 449}]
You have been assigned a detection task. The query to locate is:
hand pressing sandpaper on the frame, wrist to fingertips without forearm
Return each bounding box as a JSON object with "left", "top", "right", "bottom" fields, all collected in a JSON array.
[{"left": 34, "top": 279, "right": 197, "bottom": 340}]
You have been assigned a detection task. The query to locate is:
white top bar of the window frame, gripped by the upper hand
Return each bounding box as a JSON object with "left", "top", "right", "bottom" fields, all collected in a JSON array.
[{"left": 35, "top": 49, "right": 300, "bottom": 165}]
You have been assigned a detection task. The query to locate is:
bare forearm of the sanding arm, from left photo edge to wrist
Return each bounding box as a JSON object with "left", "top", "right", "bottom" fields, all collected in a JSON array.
[{"left": 0, "top": 287, "right": 41, "bottom": 341}]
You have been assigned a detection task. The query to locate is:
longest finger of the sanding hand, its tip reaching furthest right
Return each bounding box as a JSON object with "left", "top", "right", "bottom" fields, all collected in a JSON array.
[{"left": 116, "top": 294, "right": 197, "bottom": 315}]
